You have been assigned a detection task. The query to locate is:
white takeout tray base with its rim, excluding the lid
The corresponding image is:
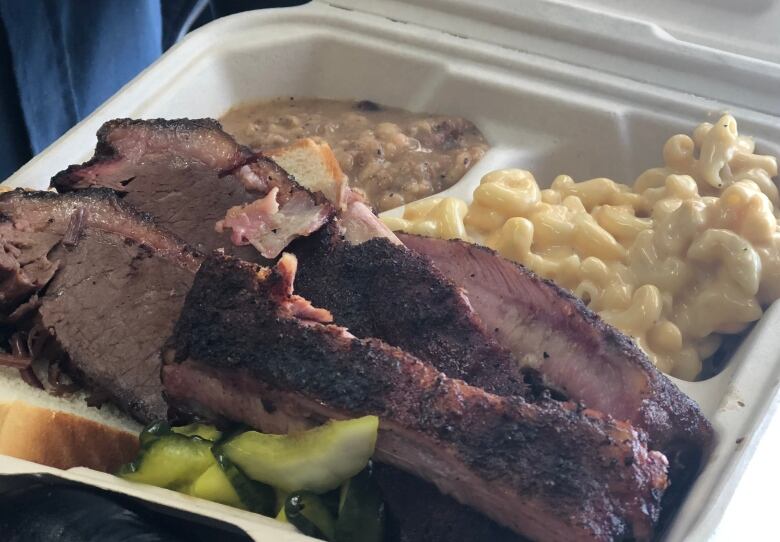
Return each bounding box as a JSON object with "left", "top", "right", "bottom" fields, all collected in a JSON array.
[{"left": 0, "top": 1, "right": 780, "bottom": 541}]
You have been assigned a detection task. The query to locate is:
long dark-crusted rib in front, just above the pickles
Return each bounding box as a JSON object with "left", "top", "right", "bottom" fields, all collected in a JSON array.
[{"left": 163, "top": 255, "right": 667, "bottom": 540}]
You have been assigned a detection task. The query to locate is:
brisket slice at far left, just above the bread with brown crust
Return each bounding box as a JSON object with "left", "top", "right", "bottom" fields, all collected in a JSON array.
[{"left": 0, "top": 189, "right": 199, "bottom": 421}]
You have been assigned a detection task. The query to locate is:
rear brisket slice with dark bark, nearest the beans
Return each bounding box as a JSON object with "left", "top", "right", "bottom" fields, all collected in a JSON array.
[{"left": 52, "top": 119, "right": 332, "bottom": 261}]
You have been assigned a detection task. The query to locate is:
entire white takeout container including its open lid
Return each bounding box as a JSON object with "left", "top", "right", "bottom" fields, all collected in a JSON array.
[{"left": 0, "top": 0, "right": 780, "bottom": 541}]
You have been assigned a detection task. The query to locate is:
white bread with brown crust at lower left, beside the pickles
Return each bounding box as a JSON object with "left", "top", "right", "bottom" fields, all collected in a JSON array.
[{"left": 0, "top": 368, "right": 140, "bottom": 472}]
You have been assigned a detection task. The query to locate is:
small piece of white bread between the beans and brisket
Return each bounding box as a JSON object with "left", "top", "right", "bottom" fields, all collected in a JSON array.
[{"left": 263, "top": 138, "right": 347, "bottom": 208}]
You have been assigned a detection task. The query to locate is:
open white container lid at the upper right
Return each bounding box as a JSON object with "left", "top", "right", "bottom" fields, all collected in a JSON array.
[{"left": 329, "top": 0, "right": 780, "bottom": 115}]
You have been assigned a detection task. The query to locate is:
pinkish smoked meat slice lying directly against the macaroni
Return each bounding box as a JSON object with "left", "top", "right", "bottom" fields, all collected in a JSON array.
[{"left": 399, "top": 234, "right": 712, "bottom": 471}]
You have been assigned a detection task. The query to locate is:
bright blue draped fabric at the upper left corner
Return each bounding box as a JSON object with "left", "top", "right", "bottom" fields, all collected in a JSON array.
[{"left": 0, "top": 0, "right": 162, "bottom": 157}]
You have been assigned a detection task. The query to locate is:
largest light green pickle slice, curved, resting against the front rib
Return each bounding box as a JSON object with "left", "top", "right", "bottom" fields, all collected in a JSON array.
[{"left": 217, "top": 416, "right": 379, "bottom": 498}]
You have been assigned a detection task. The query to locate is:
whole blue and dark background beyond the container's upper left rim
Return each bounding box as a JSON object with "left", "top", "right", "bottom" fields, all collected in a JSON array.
[{"left": 0, "top": 0, "right": 305, "bottom": 181}]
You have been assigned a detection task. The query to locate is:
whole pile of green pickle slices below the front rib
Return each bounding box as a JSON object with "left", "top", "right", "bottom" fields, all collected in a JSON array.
[{"left": 118, "top": 416, "right": 384, "bottom": 542}]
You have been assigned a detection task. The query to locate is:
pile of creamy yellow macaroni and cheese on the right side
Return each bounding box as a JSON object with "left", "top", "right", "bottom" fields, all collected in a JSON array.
[{"left": 384, "top": 115, "right": 780, "bottom": 380}]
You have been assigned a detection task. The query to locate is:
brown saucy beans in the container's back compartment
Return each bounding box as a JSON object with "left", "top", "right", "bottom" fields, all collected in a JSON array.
[{"left": 220, "top": 98, "right": 489, "bottom": 211}]
